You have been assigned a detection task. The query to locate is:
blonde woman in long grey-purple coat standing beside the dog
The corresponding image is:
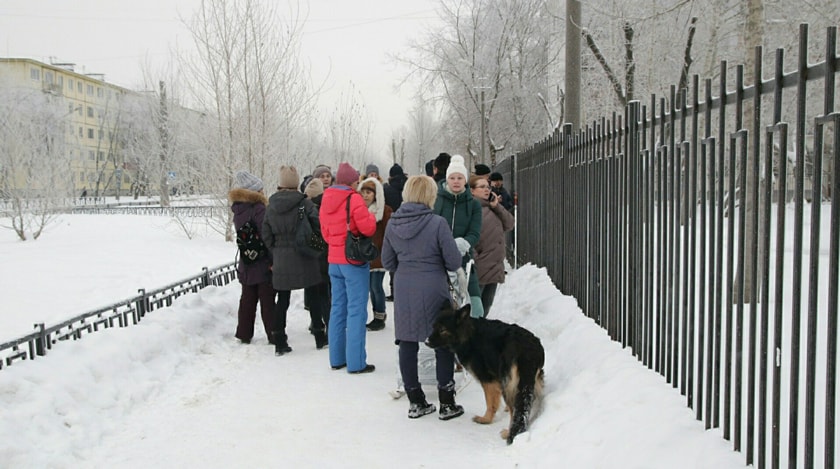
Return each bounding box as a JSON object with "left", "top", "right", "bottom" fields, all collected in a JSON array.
[{"left": 382, "top": 176, "right": 464, "bottom": 420}]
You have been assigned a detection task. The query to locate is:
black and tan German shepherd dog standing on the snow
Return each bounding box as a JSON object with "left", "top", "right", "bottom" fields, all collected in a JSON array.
[{"left": 426, "top": 303, "right": 545, "bottom": 444}]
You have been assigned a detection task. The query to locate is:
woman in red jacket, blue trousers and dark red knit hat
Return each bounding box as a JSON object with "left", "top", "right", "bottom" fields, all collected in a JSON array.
[{"left": 320, "top": 163, "right": 376, "bottom": 374}]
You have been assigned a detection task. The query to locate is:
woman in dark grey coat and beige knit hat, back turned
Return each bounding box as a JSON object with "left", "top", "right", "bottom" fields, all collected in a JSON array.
[{"left": 261, "top": 166, "right": 330, "bottom": 355}]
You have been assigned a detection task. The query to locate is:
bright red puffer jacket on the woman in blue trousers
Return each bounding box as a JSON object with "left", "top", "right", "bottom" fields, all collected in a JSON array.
[{"left": 319, "top": 186, "right": 376, "bottom": 264}]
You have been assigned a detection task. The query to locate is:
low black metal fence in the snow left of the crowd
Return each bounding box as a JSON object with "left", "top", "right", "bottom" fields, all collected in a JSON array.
[{"left": 0, "top": 263, "right": 236, "bottom": 370}]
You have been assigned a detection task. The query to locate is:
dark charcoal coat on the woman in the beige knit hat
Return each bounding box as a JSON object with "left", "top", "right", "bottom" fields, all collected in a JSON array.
[{"left": 261, "top": 190, "right": 322, "bottom": 290}]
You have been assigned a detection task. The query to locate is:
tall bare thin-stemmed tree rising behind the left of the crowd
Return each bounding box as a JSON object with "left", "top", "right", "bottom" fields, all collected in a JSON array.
[{"left": 181, "top": 0, "right": 319, "bottom": 240}]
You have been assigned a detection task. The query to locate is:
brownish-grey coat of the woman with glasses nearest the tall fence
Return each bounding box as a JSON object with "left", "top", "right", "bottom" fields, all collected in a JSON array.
[{"left": 475, "top": 196, "right": 514, "bottom": 285}]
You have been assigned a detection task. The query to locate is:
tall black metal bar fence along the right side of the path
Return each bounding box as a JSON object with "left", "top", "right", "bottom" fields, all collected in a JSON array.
[{"left": 499, "top": 25, "right": 840, "bottom": 468}]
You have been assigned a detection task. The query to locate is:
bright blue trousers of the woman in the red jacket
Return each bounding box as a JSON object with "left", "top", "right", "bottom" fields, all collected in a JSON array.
[{"left": 327, "top": 264, "right": 370, "bottom": 371}]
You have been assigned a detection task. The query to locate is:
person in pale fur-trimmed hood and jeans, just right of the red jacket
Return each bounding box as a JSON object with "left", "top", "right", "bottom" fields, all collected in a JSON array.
[{"left": 359, "top": 177, "right": 392, "bottom": 331}]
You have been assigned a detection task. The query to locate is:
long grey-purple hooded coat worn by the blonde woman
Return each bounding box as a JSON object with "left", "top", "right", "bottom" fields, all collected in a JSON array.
[{"left": 382, "top": 202, "right": 461, "bottom": 342}]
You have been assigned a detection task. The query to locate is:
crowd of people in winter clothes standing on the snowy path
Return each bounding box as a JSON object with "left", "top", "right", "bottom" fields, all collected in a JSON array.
[{"left": 228, "top": 153, "right": 514, "bottom": 420}]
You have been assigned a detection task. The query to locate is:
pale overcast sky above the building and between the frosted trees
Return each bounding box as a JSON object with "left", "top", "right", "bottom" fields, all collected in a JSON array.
[{"left": 0, "top": 0, "right": 437, "bottom": 151}]
